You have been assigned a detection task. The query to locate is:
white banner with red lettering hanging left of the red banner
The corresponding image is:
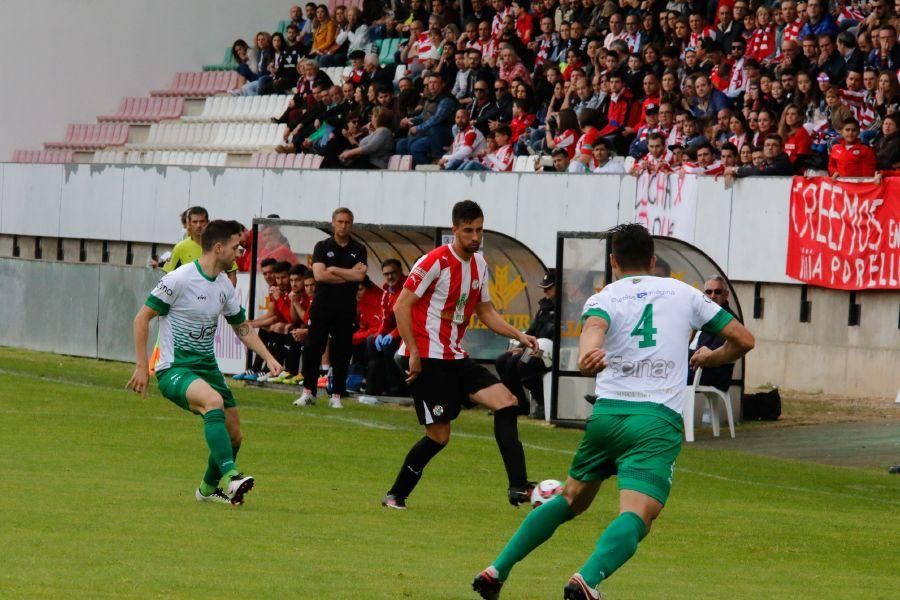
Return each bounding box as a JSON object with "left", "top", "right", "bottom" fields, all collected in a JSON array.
[{"left": 634, "top": 173, "right": 697, "bottom": 243}]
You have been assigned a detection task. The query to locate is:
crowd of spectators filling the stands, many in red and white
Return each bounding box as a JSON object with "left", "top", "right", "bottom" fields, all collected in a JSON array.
[{"left": 223, "top": 0, "right": 900, "bottom": 177}]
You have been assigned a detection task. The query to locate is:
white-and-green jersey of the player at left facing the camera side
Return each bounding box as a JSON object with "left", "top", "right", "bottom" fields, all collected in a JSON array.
[{"left": 146, "top": 260, "right": 245, "bottom": 373}]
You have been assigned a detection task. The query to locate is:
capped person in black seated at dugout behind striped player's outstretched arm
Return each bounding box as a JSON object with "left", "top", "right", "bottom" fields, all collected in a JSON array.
[{"left": 494, "top": 272, "right": 556, "bottom": 419}]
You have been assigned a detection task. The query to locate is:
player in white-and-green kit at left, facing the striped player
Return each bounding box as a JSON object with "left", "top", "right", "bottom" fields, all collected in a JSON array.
[{"left": 126, "top": 221, "right": 281, "bottom": 505}]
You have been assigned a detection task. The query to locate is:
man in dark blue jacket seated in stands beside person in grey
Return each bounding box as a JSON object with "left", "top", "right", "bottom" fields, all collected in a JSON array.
[{"left": 397, "top": 73, "right": 457, "bottom": 165}]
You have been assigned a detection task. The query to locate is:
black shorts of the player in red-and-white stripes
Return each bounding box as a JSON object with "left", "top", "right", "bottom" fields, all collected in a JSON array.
[{"left": 404, "top": 358, "right": 500, "bottom": 425}]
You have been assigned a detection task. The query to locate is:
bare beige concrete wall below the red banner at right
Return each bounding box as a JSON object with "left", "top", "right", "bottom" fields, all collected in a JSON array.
[{"left": 735, "top": 283, "right": 900, "bottom": 398}]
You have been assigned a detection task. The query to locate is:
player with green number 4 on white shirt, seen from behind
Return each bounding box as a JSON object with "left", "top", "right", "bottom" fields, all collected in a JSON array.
[{"left": 472, "top": 224, "right": 754, "bottom": 600}]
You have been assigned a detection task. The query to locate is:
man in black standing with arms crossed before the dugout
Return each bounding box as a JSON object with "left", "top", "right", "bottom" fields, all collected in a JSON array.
[{"left": 298, "top": 208, "right": 368, "bottom": 408}]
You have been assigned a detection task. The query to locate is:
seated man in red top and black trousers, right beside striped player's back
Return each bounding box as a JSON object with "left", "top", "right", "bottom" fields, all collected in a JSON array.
[{"left": 366, "top": 258, "right": 408, "bottom": 396}]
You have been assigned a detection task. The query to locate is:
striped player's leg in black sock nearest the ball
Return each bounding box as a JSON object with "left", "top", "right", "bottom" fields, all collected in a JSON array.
[{"left": 468, "top": 372, "right": 531, "bottom": 506}]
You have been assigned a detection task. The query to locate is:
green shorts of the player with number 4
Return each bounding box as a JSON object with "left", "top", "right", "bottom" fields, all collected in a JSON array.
[{"left": 569, "top": 399, "right": 682, "bottom": 504}]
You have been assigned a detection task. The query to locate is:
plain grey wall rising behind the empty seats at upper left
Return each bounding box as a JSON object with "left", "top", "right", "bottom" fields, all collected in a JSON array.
[{"left": 0, "top": 0, "right": 291, "bottom": 160}]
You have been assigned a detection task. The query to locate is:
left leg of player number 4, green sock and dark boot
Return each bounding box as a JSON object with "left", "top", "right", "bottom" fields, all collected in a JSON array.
[{"left": 472, "top": 477, "right": 601, "bottom": 598}]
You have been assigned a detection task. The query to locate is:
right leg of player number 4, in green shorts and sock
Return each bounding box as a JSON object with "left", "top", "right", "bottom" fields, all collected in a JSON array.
[{"left": 570, "top": 415, "right": 682, "bottom": 598}]
